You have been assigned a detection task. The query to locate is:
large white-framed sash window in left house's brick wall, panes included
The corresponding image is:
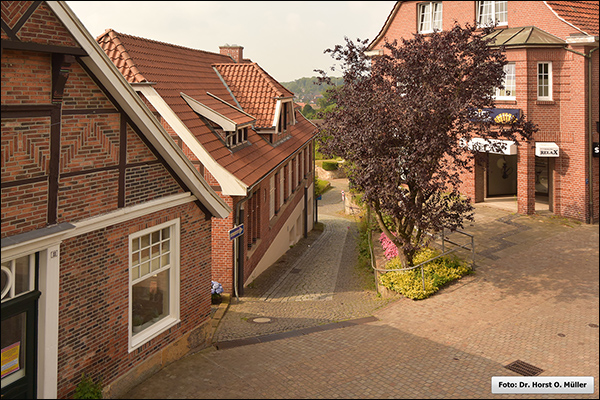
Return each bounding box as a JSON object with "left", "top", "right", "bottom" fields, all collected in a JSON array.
[{"left": 129, "top": 219, "right": 180, "bottom": 348}]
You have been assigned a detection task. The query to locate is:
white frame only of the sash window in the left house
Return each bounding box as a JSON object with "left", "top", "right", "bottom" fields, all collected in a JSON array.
[{"left": 127, "top": 218, "right": 181, "bottom": 353}]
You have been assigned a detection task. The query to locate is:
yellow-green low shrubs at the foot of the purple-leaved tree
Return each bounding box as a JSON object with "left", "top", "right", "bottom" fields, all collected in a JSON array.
[{"left": 379, "top": 248, "right": 473, "bottom": 300}]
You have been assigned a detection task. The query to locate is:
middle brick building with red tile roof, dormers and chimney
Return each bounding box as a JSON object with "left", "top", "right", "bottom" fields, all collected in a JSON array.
[{"left": 97, "top": 29, "right": 316, "bottom": 294}]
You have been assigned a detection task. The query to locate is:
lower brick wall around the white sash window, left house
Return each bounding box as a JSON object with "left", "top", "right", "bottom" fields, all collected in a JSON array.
[{"left": 57, "top": 203, "right": 211, "bottom": 398}]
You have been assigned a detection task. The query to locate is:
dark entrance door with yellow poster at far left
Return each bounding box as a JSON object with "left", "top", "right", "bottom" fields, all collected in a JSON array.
[{"left": 1, "top": 253, "right": 41, "bottom": 399}]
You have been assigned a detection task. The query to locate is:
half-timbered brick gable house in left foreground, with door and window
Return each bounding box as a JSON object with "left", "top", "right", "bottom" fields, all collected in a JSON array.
[{"left": 1, "top": 1, "right": 231, "bottom": 399}]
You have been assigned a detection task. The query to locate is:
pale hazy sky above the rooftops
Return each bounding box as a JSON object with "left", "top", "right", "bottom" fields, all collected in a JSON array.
[{"left": 66, "top": 1, "right": 396, "bottom": 82}]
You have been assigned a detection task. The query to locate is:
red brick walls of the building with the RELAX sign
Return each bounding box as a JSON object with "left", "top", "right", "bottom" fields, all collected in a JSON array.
[{"left": 369, "top": 1, "right": 599, "bottom": 222}]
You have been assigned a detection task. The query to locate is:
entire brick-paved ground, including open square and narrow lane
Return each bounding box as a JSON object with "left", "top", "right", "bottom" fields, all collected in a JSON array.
[{"left": 126, "top": 182, "right": 599, "bottom": 399}]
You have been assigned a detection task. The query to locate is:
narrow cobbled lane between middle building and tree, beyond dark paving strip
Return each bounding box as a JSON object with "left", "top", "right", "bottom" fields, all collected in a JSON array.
[{"left": 214, "top": 179, "right": 392, "bottom": 348}]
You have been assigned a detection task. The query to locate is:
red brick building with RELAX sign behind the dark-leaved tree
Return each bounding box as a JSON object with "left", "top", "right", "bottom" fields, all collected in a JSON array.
[{"left": 368, "top": 1, "right": 599, "bottom": 223}]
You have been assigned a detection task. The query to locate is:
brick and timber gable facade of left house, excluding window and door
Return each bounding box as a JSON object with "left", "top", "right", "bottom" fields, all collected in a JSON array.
[{"left": 1, "top": 1, "right": 225, "bottom": 398}]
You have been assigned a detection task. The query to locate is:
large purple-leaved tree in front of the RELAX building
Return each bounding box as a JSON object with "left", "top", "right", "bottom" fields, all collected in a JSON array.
[{"left": 316, "top": 24, "right": 537, "bottom": 267}]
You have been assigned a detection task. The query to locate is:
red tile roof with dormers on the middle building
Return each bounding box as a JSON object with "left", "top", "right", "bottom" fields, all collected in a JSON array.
[{"left": 97, "top": 30, "right": 316, "bottom": 186}]
